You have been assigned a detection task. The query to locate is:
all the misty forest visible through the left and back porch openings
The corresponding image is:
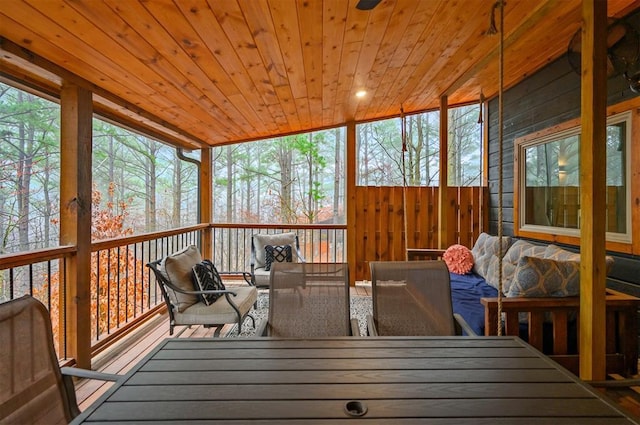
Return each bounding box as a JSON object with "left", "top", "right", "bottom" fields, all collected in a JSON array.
[{"left": 0, "top": 84, "right": 482, "bottom": 254}]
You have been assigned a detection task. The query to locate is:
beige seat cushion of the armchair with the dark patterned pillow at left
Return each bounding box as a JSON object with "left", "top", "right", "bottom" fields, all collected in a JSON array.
[{"left": 175, "top": 286, "right": 258, "bottom": 325}]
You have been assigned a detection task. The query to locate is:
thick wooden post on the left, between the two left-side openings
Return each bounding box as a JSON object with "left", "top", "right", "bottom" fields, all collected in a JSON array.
[{"left": 60, "top": 82, "right": 93, "bottom": 368}]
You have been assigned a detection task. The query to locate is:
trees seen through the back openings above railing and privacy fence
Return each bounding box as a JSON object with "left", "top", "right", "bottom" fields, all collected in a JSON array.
[{"left": 213, "top": 105, "right": 482, "bottom": 223}]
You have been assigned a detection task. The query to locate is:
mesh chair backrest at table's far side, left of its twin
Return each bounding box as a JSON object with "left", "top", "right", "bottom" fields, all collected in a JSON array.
[{"left": 268, "top": 263, "right": 351, "bottom": 338}]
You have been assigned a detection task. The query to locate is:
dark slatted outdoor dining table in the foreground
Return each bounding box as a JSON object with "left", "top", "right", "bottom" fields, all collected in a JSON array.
[{"left": 76, "top": 337, "right": 637, "bottom": 425}]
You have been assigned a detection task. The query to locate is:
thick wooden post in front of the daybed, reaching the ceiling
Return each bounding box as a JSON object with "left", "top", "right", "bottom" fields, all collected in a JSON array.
[{"left": 579, "top": 0, "right": 607, "bottom": 380}]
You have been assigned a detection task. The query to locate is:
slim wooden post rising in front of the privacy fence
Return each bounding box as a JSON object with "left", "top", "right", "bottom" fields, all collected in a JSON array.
[{"left": 438, "top": 95, "right": 451, "bottom": 249}]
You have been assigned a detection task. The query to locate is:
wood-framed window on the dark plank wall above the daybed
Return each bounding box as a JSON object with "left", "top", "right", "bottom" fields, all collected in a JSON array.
[{"left": 516, "top": 112, "right": 631, "bottom": 242}]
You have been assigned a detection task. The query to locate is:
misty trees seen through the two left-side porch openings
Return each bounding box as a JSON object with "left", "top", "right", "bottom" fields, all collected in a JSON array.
[{"left": 0, "top": 83, "right": 197, "bottom": 254}]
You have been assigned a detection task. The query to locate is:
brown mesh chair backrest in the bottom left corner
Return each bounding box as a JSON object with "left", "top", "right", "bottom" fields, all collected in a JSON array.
[{"left": 0, "top": 295, "right": 79, "bottom": 424}]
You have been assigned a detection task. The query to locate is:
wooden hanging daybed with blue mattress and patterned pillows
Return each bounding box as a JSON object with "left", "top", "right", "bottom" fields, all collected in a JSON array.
[{"left": 423, "top": 233, "right": 640, "bottom": 376}]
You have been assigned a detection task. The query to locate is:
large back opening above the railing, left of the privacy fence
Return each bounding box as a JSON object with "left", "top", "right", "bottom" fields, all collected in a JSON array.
[{"left": 213, "top": 127, "right": 346, "bottom": 224}]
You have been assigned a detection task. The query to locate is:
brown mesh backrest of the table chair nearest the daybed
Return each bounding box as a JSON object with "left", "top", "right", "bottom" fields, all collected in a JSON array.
[{"left": 370, "top": 261, "right": 456, "bottom": 336}]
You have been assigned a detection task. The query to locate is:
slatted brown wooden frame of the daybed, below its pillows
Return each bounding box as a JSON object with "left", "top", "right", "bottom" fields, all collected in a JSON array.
[{"left": 480, "top": 289, "right": 640, "bottom": 377}]
